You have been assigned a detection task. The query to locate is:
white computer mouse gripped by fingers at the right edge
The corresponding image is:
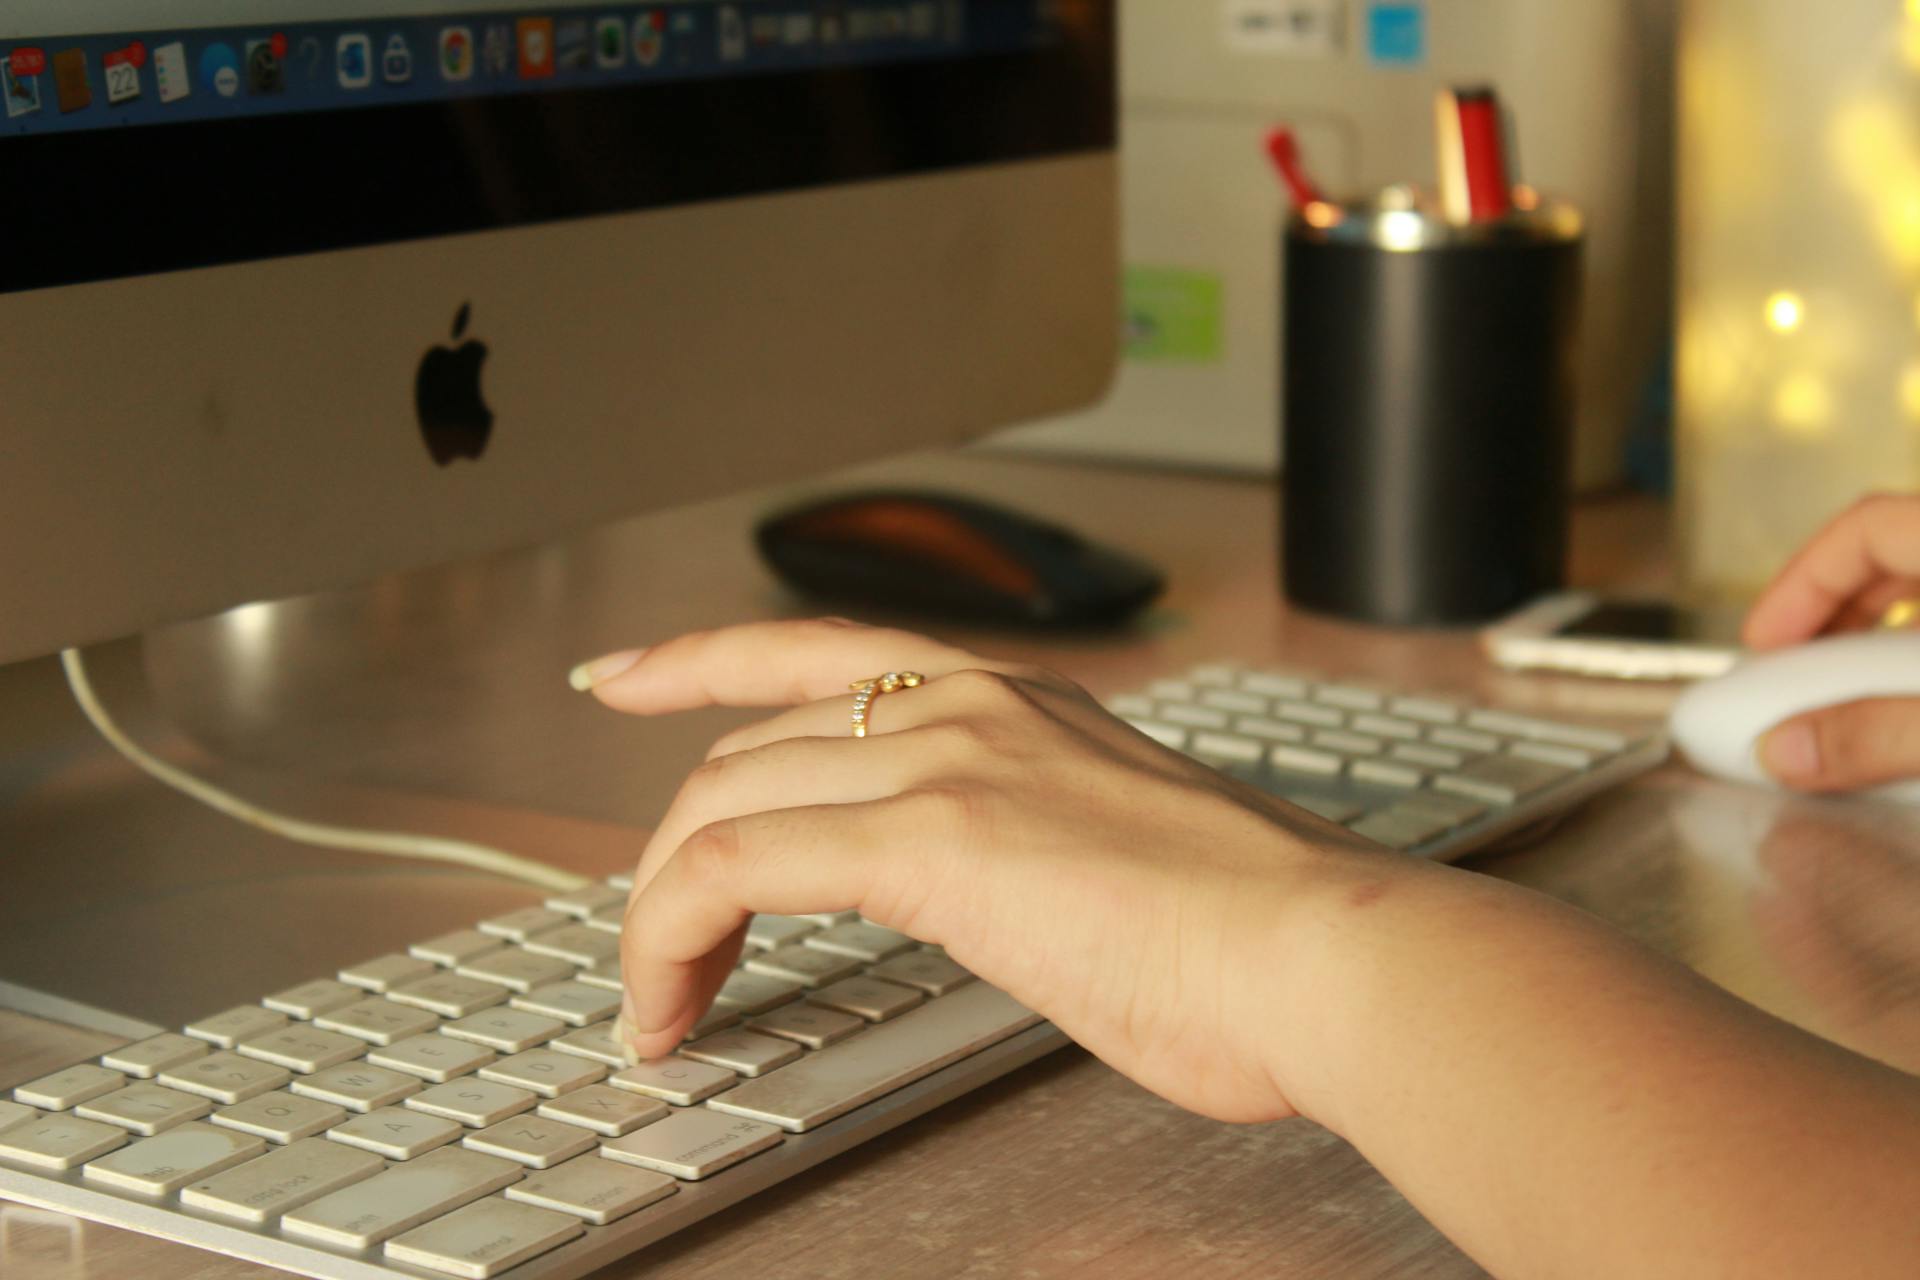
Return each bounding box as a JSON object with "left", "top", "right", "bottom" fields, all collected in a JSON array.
[{"left": 1670, "top": 631, "right": 1920, "bottom": 804}]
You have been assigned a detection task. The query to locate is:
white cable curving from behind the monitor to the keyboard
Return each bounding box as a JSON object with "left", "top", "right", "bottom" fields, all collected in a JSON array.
[{"left": 60, "top": 649, "right": 593, "bottom": 892}]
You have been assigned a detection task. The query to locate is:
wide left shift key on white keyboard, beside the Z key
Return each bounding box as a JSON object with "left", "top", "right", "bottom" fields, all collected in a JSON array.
[{"left": 280, "top": 1148, "right": 520, "bottom": 1249}]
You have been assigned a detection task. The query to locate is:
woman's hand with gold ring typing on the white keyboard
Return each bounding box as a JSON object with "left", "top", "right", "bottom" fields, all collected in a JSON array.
[{"left": 576, "top": 622, "right": 1417, "bottom": 1121}]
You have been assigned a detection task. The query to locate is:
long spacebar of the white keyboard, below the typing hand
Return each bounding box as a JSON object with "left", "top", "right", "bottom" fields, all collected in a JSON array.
[{"left": 707, "top": 983, "right": 1041, "bottom": 1134}]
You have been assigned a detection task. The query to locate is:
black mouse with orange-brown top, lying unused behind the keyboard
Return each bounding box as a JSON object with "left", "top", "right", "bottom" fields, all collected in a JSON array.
[{"left": 755, "top": 489, "right": 1165, "bottom": 628}]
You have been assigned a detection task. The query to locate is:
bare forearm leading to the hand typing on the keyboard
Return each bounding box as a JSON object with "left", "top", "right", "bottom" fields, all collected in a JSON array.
[{"left": 1275, "top": 865, "right": 1920, "bottom": 1278}]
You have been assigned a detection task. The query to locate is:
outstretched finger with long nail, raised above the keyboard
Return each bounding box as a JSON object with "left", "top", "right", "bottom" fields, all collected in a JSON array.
[{"left": 593, "top": 618, "right": 981, "bottom": 716}]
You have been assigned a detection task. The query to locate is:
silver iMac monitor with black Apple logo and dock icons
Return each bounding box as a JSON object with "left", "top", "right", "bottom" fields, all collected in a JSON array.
[{"left": 0, "top": 0, "right": 1117, "bottom": 660}]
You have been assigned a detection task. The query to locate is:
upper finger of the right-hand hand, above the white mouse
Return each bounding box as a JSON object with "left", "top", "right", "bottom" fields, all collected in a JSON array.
[{"left": 1743, "top": 495, "right": 1920, "bottom": 649}]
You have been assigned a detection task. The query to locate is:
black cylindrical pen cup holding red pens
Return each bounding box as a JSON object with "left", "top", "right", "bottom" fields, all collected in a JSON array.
[{"left": 1281, "top": 203, "right": 1582, "bottom": 626}]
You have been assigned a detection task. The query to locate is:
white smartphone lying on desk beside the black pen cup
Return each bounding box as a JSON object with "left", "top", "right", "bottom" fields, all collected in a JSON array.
[{"left": 1480, "top": 591, "right": 1741, "bottom": 679}]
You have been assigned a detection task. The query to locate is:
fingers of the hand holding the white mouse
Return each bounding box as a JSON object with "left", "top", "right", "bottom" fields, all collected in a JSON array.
[{"left": 1743, "top": 493, "right": 1920, "bottom": 791}]
